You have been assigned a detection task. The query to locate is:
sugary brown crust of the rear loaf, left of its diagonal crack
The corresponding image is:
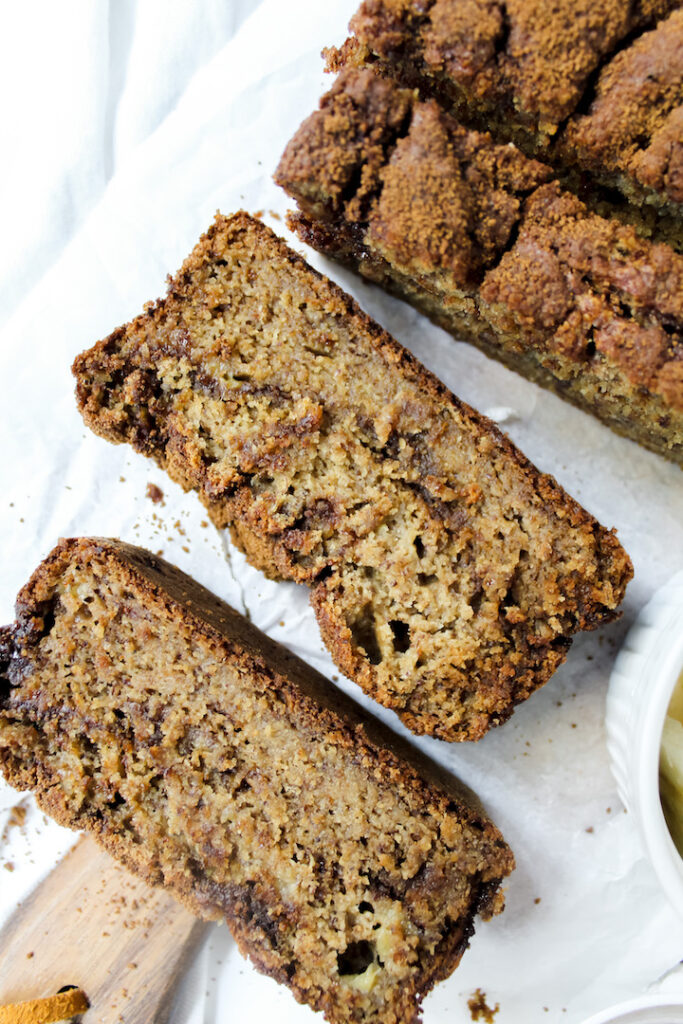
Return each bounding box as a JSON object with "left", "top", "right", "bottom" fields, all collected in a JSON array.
[{"left": 350, "top": 0, "right": 678, "bottom": 134}]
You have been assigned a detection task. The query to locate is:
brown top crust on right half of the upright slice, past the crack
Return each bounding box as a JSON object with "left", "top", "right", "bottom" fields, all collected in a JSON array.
[{"left": 481, "top": 185, "right": 683, "bottom": 413}]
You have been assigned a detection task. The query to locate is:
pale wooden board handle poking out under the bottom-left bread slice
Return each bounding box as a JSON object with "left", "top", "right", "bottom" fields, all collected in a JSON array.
[{"left": 0, "top": 838, "right": 208, "bottom": 1024}]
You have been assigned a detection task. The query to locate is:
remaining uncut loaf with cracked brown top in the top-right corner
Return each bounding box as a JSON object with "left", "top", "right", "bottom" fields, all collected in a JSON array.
[{"left": 328, "top": 0, "right": 683, "bottom": 222}]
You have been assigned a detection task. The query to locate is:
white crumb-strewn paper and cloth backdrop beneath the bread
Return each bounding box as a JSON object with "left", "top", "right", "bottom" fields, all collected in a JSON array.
[{"left": 0, "top": 0, "right": 683, "bottom": 1024}]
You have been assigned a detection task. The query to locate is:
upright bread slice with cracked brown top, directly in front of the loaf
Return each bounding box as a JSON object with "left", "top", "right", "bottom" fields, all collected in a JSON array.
[{"left": 275, "top": 69, "right": 683, "bottom": 462}]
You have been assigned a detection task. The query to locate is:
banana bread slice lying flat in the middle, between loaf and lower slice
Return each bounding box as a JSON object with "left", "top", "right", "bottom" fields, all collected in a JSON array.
[{"left": 74, "top": 213, "right": 632, "bottom": 739}]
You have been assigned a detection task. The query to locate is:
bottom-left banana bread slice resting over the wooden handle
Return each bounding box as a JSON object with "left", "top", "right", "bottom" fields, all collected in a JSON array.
[{"left": 0, "top": 539, "right": 514, "bottom": 1024}]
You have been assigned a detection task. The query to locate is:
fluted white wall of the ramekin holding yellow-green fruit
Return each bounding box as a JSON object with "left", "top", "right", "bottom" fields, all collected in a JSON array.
[{"left": 606, "top": 572, "right": 683, "bottom": 917}]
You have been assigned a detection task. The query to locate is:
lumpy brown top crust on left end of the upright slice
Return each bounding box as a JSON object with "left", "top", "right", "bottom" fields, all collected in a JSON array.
[{"left": 275, "top": 69, "right": 551, "bottom": 286}]
